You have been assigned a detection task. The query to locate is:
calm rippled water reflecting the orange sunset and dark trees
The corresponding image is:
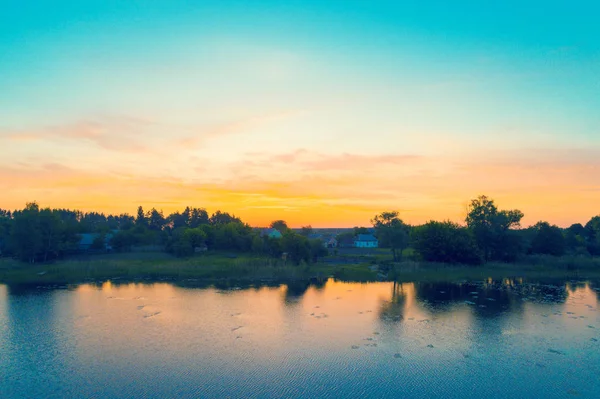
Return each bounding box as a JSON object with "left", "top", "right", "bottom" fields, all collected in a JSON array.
[{"left": 0, "top": 280, "right": 600, "bottom": 398}]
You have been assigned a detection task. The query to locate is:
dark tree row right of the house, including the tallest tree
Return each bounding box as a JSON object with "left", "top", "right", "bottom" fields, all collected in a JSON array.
[{"left": 372, "top": 195, "right": 600, "bottom": 264}]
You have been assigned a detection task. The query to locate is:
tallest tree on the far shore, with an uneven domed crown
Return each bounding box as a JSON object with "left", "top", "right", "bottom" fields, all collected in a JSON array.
[{"left": 466, "top": 195, "right": 523, "bottom": 262}]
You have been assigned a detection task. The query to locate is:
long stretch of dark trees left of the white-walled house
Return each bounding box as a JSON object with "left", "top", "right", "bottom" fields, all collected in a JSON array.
[{"left": 0, "top": 202, "right": 327, "bottom": 264}]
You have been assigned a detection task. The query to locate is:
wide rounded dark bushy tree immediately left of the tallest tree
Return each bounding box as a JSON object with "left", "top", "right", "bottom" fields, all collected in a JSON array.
[{"left": 412, "top": 221, "right": 481, "bottom": 265}]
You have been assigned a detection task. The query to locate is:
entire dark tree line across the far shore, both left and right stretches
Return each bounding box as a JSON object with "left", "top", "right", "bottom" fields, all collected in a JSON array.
[{"left": 0, "top": 196, "right": 600, "bottom": 264}]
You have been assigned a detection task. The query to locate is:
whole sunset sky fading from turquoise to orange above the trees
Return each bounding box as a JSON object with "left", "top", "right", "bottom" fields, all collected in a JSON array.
[{"left": 0, "top": 0, "right": 600, "bottom": 227}]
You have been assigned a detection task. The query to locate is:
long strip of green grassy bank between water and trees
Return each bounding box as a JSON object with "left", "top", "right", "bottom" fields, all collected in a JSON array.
[{"left": 0, "top": 253, "right": 600, "bottom": 284}]
